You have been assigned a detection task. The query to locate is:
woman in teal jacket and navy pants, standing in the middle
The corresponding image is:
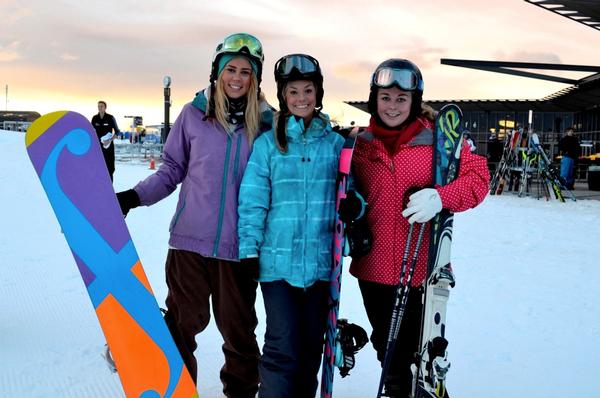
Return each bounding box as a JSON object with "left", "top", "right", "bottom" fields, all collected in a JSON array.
[{"left": 238, "top": 54, "right": 344, "bottom": 398}]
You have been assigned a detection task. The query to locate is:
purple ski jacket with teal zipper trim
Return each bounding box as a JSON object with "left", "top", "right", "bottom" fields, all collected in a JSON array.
[{"left": 134, "top": 92, "right": 272, "bottom": 261}]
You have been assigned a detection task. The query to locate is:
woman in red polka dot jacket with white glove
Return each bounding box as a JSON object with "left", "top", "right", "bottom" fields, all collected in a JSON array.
[{"left": 342, "top": 59, "right": 489, "bottom": 398}]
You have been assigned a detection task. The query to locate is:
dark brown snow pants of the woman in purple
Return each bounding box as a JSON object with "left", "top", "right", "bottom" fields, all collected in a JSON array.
[{"left": 165, "top": 249, "right": 260, "bottom": 398}]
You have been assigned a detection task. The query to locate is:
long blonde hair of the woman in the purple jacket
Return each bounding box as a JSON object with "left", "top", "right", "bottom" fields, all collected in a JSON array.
[{"left": 214, "top": 73, "right": 264, "bottom": 146}]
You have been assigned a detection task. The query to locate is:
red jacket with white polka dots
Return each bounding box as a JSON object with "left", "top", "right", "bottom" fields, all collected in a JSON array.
[{"left": 350, "top": 117, "right": 490, "bottom": 286}]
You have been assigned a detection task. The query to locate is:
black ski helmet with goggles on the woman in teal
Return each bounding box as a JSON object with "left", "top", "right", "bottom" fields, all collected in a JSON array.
[{"left": 275, "top": 54, "right": 324, "bottom": 112}]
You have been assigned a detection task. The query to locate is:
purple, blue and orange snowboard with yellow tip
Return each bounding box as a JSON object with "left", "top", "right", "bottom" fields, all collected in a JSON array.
[{"left": 25, "top": 111, "right": 198, "bottom": 398}]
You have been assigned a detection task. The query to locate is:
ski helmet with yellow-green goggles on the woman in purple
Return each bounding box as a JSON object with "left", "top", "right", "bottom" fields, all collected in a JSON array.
[{"left": 210, "top": 33, "right": 265, "bottom": 86}]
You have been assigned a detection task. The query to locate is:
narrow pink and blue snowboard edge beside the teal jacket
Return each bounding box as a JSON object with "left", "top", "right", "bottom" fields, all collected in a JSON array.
[{"left": 321, "top": 134, "right": 356, "bottom": 398}]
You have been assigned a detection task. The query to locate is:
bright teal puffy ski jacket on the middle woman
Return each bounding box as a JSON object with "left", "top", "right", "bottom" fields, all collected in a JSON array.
[{"left": 238, "top": 116, "right": 344, "bottom": 288}]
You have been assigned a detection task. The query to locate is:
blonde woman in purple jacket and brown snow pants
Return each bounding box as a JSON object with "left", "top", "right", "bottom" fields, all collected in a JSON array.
[{"left": 117, "top": 33, "right": 272, "bottom": 398}]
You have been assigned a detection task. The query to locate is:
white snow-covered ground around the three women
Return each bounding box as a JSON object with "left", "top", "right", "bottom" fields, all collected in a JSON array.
[{"left": 0, "top": 131, "right": 600, "bottom": 398}]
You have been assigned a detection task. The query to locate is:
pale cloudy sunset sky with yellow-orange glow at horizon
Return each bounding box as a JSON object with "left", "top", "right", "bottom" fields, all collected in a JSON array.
[{"left": 0, "top": 0, "right": 600, "bottom": 129}]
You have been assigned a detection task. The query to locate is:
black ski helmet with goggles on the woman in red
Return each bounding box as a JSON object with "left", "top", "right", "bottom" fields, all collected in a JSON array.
[{"left": 368, "top": 58, "right": 424, "bottom": 122}]
